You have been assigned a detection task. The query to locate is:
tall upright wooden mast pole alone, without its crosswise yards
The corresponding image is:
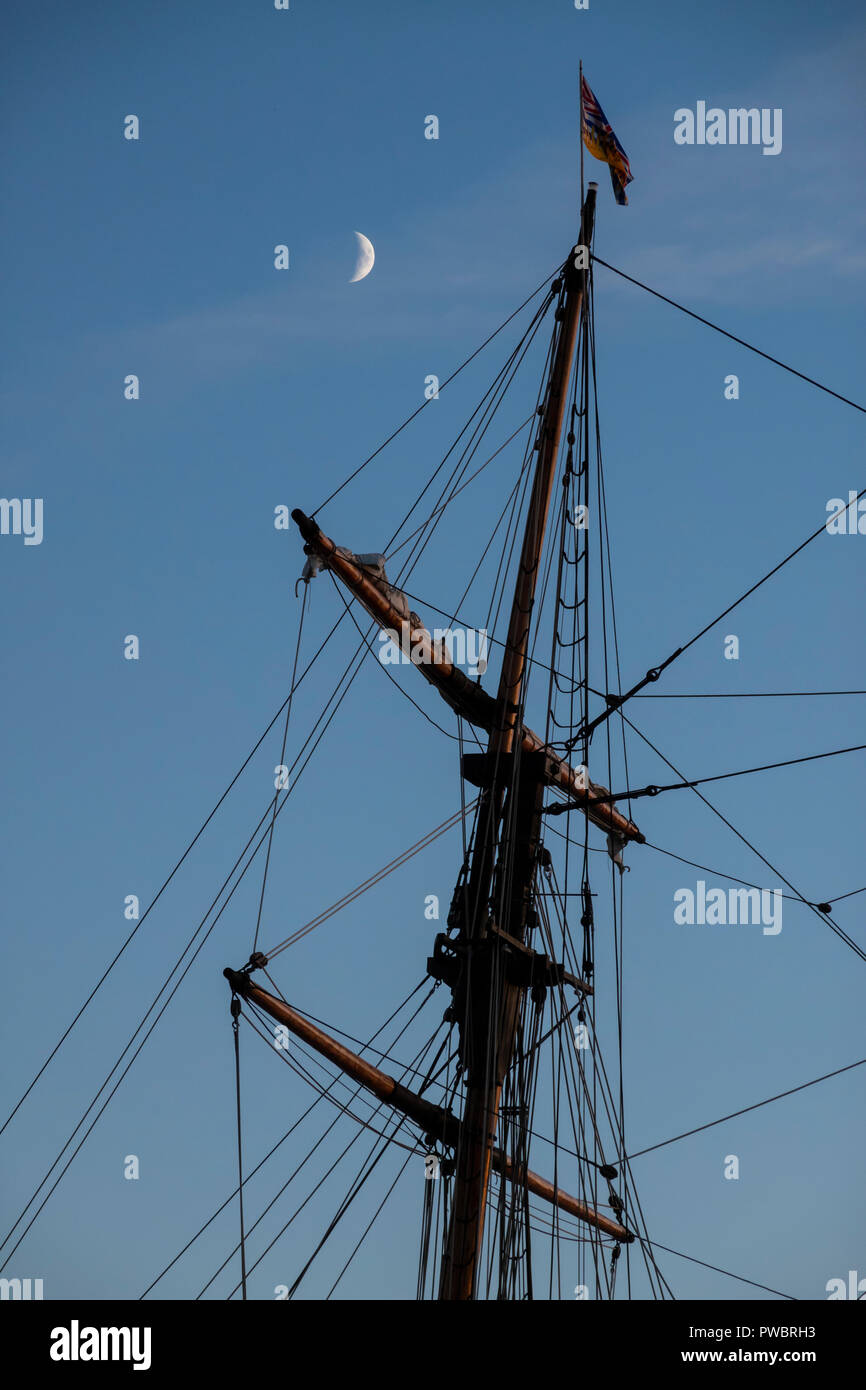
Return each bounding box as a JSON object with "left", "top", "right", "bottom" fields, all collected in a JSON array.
[{"left": 439, "top": 183, "right": 596, "bottom": 1300}]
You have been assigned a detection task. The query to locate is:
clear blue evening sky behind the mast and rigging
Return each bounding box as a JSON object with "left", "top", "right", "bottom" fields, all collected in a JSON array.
[{"left": 0, "top": 0, "right": 866, "bottom": 1298}]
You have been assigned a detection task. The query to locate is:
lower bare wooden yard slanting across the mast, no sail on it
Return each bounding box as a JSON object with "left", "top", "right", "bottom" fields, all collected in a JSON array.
[{"left": 222, "top": 969, "right": 634, "bottom": 1244}]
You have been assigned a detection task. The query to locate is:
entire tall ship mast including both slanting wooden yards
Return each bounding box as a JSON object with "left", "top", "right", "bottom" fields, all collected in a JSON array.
[{"left": 225, "top": 182, "right": 653, "bottom": 1300}]
